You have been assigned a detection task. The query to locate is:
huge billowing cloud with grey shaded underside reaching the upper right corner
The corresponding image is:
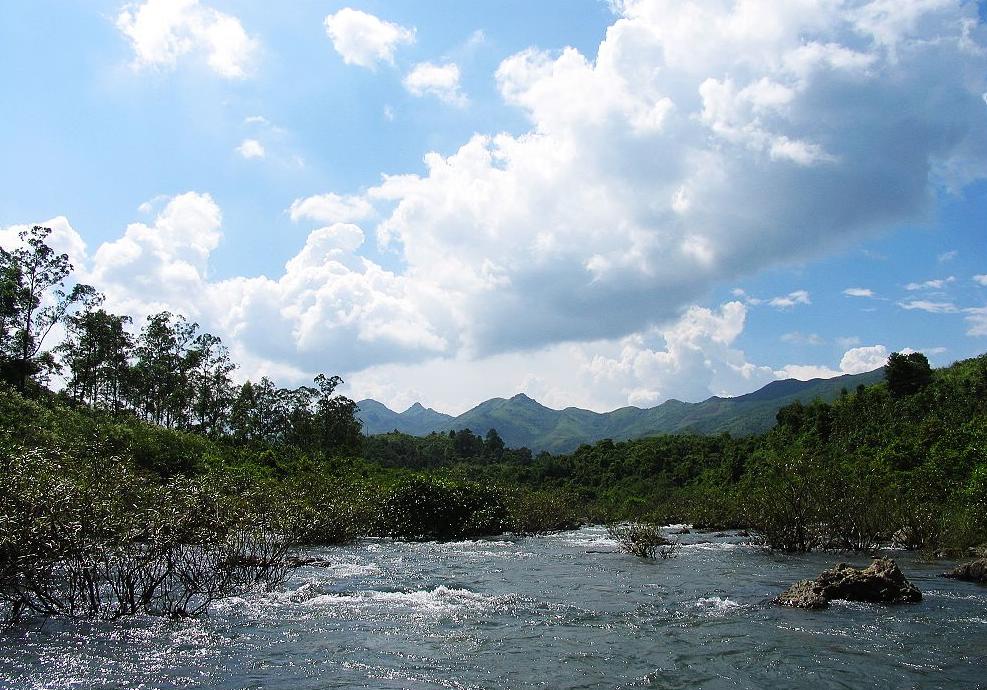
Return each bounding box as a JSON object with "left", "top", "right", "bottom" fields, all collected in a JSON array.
[{"left": 350, "top": 2, "right": 987, "bottom": 354}]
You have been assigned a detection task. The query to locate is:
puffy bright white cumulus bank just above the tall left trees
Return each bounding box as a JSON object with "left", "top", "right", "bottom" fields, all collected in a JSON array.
[{"left": 20, "top": 192, "right": 446, "bottom": 380}]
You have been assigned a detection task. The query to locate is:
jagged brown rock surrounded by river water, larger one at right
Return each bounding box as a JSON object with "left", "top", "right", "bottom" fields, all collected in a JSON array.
[{"left": 775, "top": 558, "right": 922, "bottom": 609}]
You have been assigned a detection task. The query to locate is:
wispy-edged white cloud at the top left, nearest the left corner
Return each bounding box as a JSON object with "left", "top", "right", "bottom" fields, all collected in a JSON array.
[{"left": 116, "top": 0, "right": 258, "bottom": 79}]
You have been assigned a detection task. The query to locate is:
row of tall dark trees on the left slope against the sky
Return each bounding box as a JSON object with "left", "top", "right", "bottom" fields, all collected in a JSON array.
[{"left": 0, "top": 226, "right": 360, "bottom": 454}]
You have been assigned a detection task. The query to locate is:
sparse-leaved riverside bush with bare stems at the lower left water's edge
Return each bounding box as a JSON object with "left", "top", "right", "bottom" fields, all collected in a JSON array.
[{"left": 0, "top": 449, "right": 302, "bottom": 620}]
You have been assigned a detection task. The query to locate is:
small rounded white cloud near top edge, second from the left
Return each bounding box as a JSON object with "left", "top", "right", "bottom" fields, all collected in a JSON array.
[{"left": 325, "top": 7, "right": 415, "bottom": 69}]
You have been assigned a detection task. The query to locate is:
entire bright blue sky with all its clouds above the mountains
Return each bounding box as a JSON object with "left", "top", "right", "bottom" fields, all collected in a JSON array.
[{"left": 0, "top": 0, "right": 987, "bottom": 412}]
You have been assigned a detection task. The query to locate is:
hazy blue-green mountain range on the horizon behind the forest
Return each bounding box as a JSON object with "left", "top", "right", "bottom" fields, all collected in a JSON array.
[{"left": 357, "top": 369, "right": 884, "bottom": 453}]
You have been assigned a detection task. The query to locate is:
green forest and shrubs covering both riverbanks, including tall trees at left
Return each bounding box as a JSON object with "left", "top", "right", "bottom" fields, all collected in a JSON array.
[{"left": 0, "top": 227, "right": 987, "bottom": 619}]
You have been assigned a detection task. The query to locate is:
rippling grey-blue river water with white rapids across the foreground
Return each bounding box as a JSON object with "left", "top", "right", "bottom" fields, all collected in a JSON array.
[{"left": 0, "top": 527, "right": 987, "bottom": 690}]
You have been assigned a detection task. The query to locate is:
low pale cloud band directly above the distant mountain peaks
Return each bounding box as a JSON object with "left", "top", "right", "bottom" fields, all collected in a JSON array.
[{"left": 349, "top": 302, "right": 788, "bottom": 414}]
